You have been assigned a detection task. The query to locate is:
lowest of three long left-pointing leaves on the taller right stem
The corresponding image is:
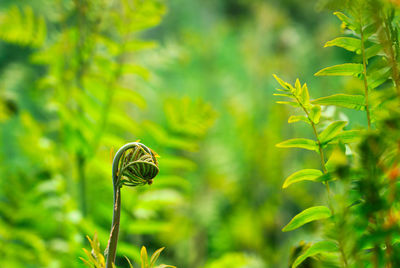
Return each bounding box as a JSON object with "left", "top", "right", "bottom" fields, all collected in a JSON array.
[{"left": 311, "top": 94, "right": 365, "bottom": 111}]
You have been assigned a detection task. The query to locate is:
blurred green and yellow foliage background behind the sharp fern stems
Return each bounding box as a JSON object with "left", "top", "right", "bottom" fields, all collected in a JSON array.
[{"left": 0, "top": 0, "right": 365, "bottom": 268}]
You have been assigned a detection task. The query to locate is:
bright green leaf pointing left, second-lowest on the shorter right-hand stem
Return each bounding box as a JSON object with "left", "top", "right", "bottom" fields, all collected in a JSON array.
[{"left": 282, "top": 206, "right": 332, "bottom": 232}]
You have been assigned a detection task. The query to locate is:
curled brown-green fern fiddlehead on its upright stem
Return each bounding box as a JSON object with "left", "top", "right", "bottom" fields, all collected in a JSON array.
[{"left": 105, "top": 142, "right": 159, "bottom": 268}]
